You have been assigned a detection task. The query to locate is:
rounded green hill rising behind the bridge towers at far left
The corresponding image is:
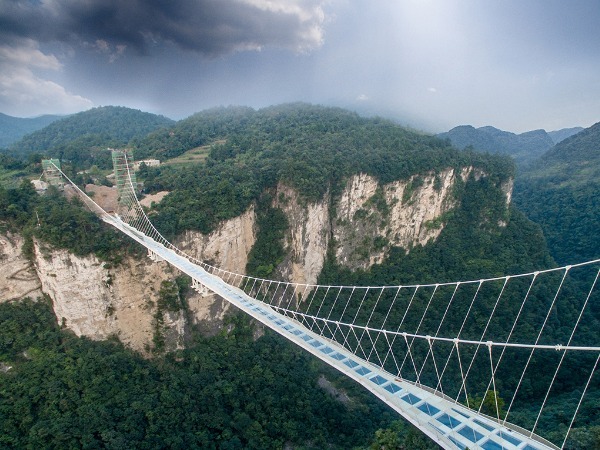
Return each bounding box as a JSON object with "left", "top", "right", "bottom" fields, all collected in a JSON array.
[{"left": 9, "top": 106, "right": 175, "bottom": 167}]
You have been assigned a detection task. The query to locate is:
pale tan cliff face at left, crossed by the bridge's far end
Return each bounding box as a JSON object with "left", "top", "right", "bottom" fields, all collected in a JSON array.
[{"left": 0, "top": 208, "right": 256, "bottom": 352}]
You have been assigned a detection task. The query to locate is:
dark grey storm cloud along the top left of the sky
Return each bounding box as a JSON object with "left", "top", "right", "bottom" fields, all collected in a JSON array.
[{"left": 0, "top": 0, "right": 323, "bottom": 56}]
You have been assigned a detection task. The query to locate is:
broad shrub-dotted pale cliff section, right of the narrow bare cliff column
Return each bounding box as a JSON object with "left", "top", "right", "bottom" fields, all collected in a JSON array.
[{"left": 333, "top": 169, "right": 464, "bottom": 269}]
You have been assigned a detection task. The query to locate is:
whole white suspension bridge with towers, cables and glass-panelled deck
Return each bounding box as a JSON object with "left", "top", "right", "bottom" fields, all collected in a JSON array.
[{"left": 44, "top": 155, "right": 600, "bottom": 450}]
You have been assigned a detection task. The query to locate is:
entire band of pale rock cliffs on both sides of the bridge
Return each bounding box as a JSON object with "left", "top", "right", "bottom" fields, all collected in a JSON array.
[{"left": 0, "top": 168, "right": 512, "bottom": 352}]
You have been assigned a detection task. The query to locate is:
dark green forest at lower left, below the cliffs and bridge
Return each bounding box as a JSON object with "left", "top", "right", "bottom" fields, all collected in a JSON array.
[{"left": 0, "top": 300, "right": 408, "bottom": 450}]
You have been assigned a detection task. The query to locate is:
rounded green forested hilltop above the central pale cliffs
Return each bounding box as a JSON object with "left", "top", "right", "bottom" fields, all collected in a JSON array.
[{"left": 139, "top": 104, "right": 513, "bottom": 235}]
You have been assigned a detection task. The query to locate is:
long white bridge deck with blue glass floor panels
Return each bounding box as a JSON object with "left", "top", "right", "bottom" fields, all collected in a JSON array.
[{"left": 103, "top": 215, "right": 558, "bottom": 450}]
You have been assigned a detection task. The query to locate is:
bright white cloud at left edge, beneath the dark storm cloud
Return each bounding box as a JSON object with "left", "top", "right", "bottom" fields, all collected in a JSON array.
[{"left": 0, "top": 40, "right": 92, "bottom": 116}]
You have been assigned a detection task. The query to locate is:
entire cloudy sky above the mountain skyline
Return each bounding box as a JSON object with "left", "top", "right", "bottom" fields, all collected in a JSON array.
[{"left": 0, "top": 0, "right": 600, "bottom": 133}]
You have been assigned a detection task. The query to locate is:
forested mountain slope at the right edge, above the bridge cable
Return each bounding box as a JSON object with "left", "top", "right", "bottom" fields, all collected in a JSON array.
[{"left": 514, "top": 122, "right": 600, "bottom": 264}]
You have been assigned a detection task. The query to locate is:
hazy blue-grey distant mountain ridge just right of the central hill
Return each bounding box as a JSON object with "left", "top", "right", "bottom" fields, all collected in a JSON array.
[{"left": 438, "top": 125, "right": 554, "bottom": 166}]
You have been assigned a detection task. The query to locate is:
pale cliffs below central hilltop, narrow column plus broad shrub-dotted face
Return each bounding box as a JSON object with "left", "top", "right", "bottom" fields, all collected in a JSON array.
[{"left": 273, "top": 167, "right": 500, "bottom": 274}]
